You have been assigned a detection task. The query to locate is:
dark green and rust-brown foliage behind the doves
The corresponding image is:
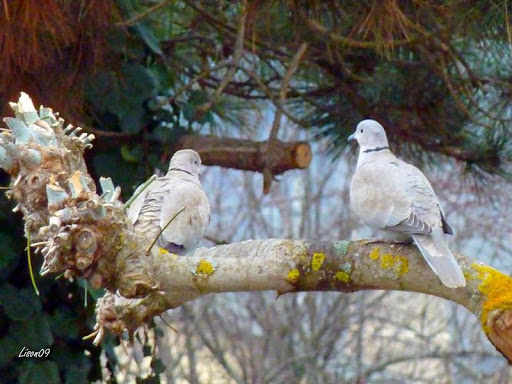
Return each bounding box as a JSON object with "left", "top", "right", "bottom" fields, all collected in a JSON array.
[{"left": 0, "top": 0, "right": 512, "bottom": 383}]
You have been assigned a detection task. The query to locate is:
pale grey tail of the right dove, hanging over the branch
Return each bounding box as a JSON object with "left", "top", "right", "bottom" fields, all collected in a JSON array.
[{"left": 412, "top": 233, "right": 466, "bottom": 288}]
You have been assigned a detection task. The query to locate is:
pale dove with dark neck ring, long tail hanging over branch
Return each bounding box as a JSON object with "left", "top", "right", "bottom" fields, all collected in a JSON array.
[{"left": 349, "top": 120, "right": 466, "bottom": 288}]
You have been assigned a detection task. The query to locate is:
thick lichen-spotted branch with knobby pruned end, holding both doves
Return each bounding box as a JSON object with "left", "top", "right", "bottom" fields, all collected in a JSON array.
[{"left": 0, "top": 94, "right": 512, "bottom": 361}]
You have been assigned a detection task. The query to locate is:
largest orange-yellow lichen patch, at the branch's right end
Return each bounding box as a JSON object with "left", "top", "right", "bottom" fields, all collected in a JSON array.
[{"left": 471, "top": 263, "right": 512, "bottom": 333}]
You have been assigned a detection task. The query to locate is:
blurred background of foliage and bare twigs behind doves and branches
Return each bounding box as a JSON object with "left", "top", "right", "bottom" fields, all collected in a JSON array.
[{"left": 0, "top": 0, "right": 512, "bottom": 384}]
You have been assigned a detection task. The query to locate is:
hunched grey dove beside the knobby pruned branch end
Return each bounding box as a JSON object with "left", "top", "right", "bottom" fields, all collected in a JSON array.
[{"left": 128, "top": 149, "right": 210, "bottom": 255}]
